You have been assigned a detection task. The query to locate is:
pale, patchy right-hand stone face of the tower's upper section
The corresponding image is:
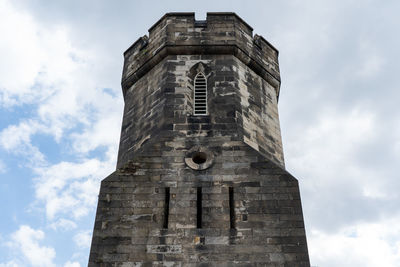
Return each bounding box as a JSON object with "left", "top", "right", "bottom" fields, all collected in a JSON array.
[{"left": 233, "top": 58, "right": 285, "bottom": 167}]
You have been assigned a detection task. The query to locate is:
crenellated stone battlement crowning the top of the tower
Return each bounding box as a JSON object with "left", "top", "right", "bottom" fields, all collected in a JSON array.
[{"left": 122, "top": 12, "right": 280, "bottom": 96}]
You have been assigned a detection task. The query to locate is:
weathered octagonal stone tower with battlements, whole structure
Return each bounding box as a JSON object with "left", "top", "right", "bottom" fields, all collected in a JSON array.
[{"left": 89, "top": 13, "right": 309, "bottom": 267}]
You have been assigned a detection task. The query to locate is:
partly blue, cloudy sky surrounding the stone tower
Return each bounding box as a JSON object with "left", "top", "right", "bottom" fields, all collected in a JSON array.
[{"left": 0, "top": 0, "right": 400, "bottom": 267}]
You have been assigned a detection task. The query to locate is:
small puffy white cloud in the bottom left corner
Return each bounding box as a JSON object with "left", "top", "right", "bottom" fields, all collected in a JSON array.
[{"left": 9, "top": 225, "right": 56, "bottom": 267}]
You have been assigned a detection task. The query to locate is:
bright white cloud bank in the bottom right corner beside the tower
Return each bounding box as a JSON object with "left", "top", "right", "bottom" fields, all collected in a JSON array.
[{"left": 308, "top": 218, "right": 400, "bottom": 267}]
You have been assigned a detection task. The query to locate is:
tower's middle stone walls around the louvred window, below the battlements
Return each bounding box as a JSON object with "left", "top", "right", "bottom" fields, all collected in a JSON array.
[{"left": 118, "top": 55, "right": 284, "bottom": 170}]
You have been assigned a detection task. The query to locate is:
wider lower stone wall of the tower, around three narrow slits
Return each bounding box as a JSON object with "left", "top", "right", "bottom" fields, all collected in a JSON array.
[{"left": 89, "top": 137, "right": 309, "bottom": 267}]
